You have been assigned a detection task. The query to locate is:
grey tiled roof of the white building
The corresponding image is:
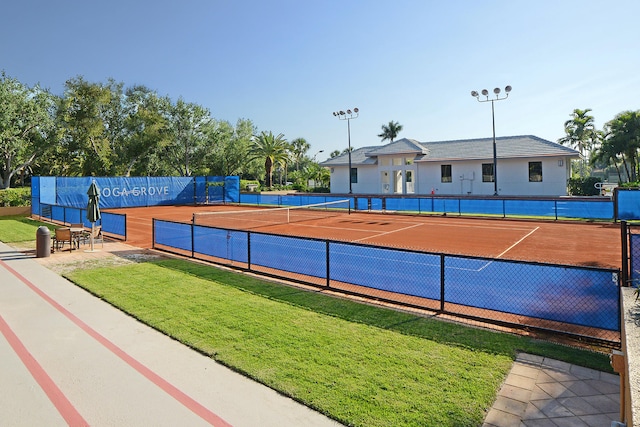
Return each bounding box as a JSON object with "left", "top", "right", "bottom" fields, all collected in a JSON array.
[{"left": 321, "top": 135, "right": 580, "bottom": 166}]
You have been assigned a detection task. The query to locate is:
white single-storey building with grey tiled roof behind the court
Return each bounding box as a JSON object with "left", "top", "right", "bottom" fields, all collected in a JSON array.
[{"left": 320, "top": 135, "right": 580, "bottom": 196}]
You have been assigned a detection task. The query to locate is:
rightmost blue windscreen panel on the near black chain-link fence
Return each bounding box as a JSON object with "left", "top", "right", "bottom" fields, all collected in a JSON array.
[{"left": 445, "top": 256, "right": 619, "bottom": 331}]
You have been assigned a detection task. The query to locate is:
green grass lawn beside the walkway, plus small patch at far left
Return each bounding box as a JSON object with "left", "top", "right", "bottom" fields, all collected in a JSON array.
[{"left": 0, "top": 219, "right": 610, "bottom": 427}]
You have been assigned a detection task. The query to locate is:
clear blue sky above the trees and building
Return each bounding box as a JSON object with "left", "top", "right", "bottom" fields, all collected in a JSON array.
[{"left": 0, "top": 0, "right": 640, "bottom": 160}]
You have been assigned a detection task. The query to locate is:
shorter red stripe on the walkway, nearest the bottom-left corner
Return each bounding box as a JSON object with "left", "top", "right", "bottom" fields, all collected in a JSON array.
[{"left": 0, "top": 316, "right": 89, "bottom": 426}]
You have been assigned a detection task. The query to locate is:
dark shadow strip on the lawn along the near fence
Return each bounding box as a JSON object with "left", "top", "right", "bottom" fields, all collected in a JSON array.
[{"left": 154, "top": 259, "right": 611, "bottom": 371}]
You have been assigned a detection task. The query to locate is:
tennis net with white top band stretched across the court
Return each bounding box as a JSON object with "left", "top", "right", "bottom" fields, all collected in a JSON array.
[{"left": 193, "top": 200, "right": 351, "bottom": 230}]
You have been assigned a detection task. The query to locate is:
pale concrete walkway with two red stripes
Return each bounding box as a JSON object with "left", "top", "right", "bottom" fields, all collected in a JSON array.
[{"left": 0, "top": 243, "right": 339, "bottom": 427}]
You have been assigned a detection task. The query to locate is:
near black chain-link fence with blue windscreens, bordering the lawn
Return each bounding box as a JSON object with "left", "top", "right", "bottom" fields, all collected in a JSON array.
[{"left": 153, "top": 219, "right": 620, "bottom": 346}]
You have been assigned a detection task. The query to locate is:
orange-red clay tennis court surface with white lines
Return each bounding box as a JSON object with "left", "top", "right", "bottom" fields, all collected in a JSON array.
[{"left": 113, "top": 205, "right": 621, "bottom": 269}]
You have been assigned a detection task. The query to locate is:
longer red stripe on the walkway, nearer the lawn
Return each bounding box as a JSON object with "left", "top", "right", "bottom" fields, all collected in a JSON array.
[{"left": 0, "top": 260, "right": 231, "bottom": 427}]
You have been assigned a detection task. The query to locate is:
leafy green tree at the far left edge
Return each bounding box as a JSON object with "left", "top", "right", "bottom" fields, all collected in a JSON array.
[{"left": 0, "top": 72, "right": 54, "bottom": 188}]
